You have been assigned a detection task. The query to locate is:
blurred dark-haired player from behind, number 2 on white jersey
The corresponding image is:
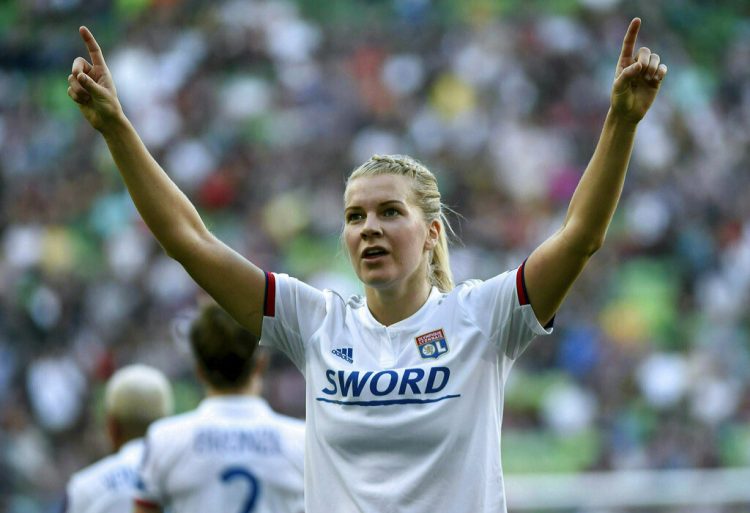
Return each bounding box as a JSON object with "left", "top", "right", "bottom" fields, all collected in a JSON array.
[{"left": 135, "top": 303, "right": 305, "bottom": 513}]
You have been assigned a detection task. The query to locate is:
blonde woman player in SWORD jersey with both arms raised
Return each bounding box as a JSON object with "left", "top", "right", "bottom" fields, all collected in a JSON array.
[{"left": 68, "top": 18, "right": 667, "bottom": 513}]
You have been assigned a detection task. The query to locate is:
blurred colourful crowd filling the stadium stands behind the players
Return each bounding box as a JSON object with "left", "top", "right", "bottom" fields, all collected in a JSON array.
[{"left": 0, "top": 0, "right": 750, "bottom": 513}]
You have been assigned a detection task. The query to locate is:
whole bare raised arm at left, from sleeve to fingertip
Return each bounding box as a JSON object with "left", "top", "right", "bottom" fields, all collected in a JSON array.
[{"left": 68, "top": 27, "right": 265, "bottom": 336}]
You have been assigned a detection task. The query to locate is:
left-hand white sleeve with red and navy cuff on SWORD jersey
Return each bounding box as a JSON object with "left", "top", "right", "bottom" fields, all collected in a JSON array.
[{"left": 260, "top": 273, "right": 326, "bottom": 374}]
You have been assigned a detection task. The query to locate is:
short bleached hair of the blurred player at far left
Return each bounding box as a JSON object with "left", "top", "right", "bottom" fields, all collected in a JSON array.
[{"left": 104, "top": 364, "right": 174, "bottom": 428}]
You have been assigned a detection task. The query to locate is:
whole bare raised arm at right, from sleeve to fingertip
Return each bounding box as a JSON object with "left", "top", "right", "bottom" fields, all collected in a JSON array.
[{"left": 524, "top": 18, "right": 667, "bottom": 324}]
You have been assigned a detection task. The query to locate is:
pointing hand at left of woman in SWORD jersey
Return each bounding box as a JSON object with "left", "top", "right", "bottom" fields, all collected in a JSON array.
[{"left": 68, "top": 27, "right": 122, "bottom": 132}]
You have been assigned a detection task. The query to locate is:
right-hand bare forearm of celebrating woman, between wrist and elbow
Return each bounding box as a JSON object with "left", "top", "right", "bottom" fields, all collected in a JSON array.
[{"left": 562, "top": 111, "right": 637, "bottom": 254}]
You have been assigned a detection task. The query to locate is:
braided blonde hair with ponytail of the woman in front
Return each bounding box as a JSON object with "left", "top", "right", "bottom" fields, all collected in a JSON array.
[{"left": 346, "top": 155, "right": 453, "bottom": 292}]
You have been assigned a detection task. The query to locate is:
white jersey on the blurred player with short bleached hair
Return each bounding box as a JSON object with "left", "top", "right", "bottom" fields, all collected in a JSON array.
[{"left": 64, "top": 438, "right": 143, "bottom": 513}]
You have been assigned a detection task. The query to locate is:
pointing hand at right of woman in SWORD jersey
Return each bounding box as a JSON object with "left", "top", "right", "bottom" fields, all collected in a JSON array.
[{"left": 610, "top": 18, "right": 667, "bottom": 123}]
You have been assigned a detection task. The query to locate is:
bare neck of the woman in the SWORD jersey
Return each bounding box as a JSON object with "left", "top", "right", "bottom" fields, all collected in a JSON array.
[{"left": 365, "top": 280, "right": 432, "bottom": 326}]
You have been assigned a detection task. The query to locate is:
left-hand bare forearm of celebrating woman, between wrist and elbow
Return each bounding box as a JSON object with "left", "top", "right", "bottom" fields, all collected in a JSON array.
[{"left": 101, "top": 114, "right": 207, "bottom": 260}]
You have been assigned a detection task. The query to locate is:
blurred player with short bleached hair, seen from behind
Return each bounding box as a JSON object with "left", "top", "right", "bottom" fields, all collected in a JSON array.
[{"left": 63, "top": 364, "right": 173, "bottom": 513}]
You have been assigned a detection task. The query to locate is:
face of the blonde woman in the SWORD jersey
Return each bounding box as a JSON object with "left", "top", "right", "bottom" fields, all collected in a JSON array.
[{"left": 344, "top": 174, "right": 439, "bottom": 289}]
